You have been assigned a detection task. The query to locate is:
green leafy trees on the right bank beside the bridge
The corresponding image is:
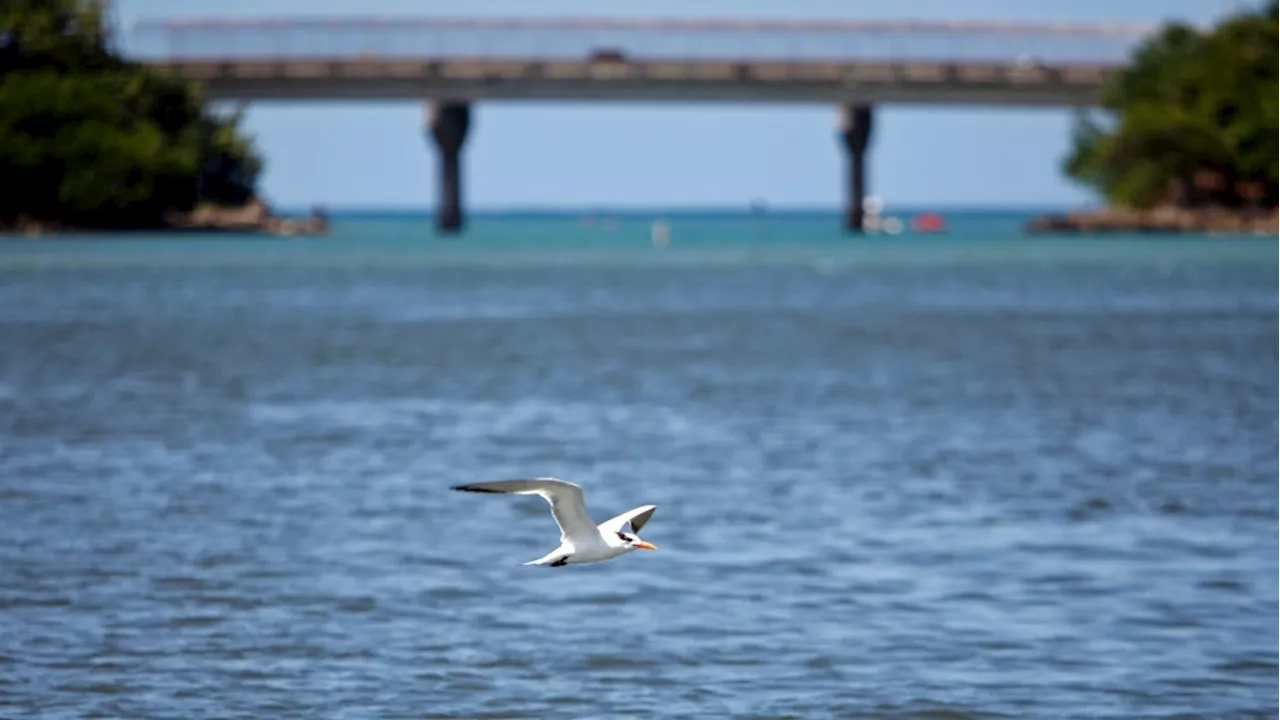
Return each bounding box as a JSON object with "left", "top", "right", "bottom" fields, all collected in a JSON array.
[{"left": 1064, "top": 0, "right": 1280, "bottom": 208}]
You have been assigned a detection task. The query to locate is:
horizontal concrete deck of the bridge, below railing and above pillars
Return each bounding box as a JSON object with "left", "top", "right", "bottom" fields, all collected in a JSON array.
[{"left": 145, "top": 58, "right": 1111, "bottom": 105}]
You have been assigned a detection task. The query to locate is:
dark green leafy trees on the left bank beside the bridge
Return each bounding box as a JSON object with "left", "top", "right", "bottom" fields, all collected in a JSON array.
[{"left": 0, "top": 0, "right": 262, "bottom": 228}]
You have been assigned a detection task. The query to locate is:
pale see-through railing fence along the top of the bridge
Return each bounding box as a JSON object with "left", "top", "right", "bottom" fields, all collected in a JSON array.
[{"left": 127, "top": 17, "right": 1155, "bottom": 65}]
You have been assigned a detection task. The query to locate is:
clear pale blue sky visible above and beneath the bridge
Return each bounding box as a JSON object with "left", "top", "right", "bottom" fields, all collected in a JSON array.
[{"left": 115, "top": 0, "right": 1243, "bottom": 209}]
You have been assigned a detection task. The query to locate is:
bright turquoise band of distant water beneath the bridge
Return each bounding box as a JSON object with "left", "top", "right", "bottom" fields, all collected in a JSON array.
[{"left": 0, "top": 211, "right": 1280, "bottom": 272}]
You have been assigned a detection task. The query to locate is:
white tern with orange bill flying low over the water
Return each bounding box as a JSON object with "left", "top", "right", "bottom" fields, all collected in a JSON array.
[{"left": 453, "top": 478, "right": 658, "bottom": 568}]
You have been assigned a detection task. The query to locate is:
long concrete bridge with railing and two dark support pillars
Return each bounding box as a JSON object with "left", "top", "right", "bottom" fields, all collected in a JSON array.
[{"left": 128, "top": 18, "right": 1156, "bottom": 232}]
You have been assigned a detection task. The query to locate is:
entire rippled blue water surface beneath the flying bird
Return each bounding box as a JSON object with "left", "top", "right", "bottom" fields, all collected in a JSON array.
[{"left": 0, "top": 214, "right": 1280, "bottom": 720}]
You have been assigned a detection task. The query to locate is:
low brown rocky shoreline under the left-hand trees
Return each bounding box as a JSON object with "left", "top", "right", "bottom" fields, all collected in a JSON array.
[{"left": 0, "top": 200, "right": 329, "bottom": 237}]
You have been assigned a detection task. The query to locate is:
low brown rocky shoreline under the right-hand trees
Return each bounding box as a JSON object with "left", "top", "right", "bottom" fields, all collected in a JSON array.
[{"left": 1027, "top": 208, "right": 1280, "bottom": 234}]
